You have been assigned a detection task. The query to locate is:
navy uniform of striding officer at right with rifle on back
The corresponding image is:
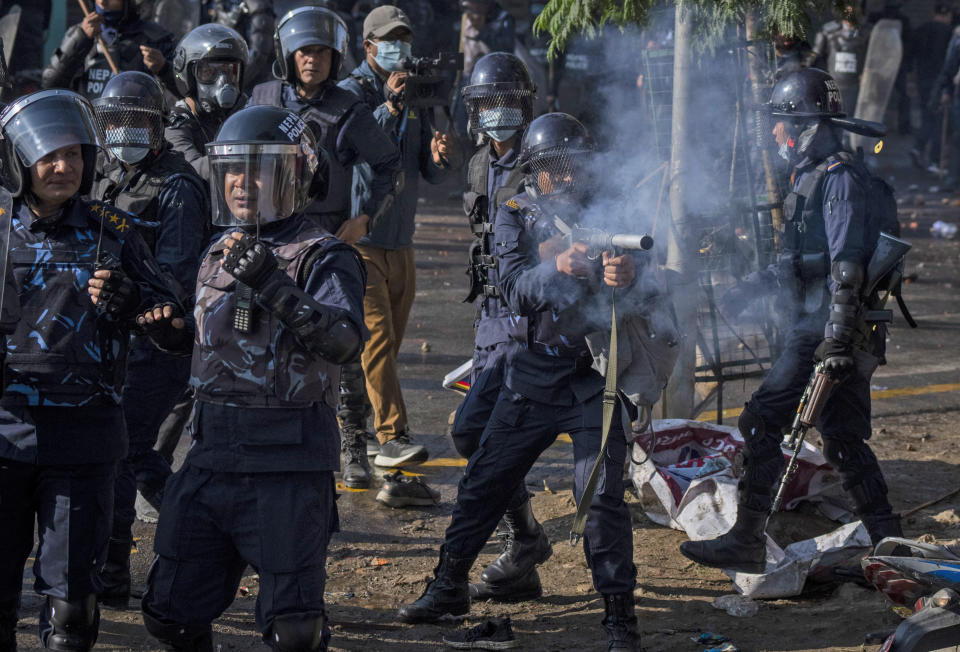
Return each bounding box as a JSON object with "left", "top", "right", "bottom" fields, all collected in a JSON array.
[{"left": 741, "top": 159, "right": 899, "bottom": 541}]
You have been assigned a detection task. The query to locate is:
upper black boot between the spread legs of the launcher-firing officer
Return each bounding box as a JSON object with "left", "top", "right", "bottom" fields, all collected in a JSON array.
[{"left": 480, "top": 497, "right": 553, "bottom": 584}]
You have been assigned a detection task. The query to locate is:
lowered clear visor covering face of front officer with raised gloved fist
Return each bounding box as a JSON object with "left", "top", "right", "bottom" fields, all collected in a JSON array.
[{"left": 207, "top": 143, "right": 303, "bottom": 226}]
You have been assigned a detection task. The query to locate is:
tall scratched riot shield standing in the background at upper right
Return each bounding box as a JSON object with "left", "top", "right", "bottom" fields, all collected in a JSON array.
[{"left": 856, "top": 18, "right": 903, "bottom": 152}]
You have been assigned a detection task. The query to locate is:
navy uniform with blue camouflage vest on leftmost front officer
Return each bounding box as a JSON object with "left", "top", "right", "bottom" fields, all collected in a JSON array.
[{"left": 0, "top": 200, "right": 175, "bottom": 633}]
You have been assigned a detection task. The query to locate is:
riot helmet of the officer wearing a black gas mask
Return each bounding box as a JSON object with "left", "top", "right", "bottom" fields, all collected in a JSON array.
[{"left": 173, "top": 23, "right": 250, "bottom": 114}]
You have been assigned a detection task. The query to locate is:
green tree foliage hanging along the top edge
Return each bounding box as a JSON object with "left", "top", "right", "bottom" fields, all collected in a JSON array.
[{"left": 533, "top": 0, "right": 858, "bottom": 57}]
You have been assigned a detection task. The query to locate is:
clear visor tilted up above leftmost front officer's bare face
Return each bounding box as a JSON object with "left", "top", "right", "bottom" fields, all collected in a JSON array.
[{"left": 0, "top": 89, "right": 102, "bottom": 167}]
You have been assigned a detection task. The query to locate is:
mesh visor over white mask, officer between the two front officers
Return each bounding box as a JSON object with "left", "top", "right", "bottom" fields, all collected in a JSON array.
[{"left": 93, "top": 97, "right": 163, "bottom": 150}]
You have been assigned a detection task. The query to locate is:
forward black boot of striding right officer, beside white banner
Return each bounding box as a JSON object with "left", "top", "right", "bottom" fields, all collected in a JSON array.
[{"left": 680, "top": 503, "right": 767, "bottom": 573}]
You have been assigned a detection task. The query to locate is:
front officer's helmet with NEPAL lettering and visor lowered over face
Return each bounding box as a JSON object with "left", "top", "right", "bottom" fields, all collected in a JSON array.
[{"left": 207, "top": 105, "right": 328, "bottom": 226}]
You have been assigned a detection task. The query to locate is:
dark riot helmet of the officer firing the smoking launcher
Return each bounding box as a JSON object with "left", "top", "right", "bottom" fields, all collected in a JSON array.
[{"left": 517, "top": 113, "right": 596, "bottom": 196}]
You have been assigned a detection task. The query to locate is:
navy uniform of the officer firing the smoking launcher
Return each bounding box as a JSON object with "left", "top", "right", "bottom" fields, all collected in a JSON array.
[{"left": 444, "top": 196, "right": 636, "bottom": 594}]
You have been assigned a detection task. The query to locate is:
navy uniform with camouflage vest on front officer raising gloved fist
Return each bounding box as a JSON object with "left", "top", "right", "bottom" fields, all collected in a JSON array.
[{"left": 143, "top": 215, "right": 364, "bottom": 640}]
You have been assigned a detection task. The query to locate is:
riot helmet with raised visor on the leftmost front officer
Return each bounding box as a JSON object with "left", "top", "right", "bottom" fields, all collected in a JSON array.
[{"left": 0, "top": 89, "right": 103, "bottom": 197}]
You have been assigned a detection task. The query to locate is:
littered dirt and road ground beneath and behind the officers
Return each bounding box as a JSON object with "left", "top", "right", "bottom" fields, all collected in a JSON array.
[{"left": 11, "top": 134, "right": 960, "bottom": 652}]
